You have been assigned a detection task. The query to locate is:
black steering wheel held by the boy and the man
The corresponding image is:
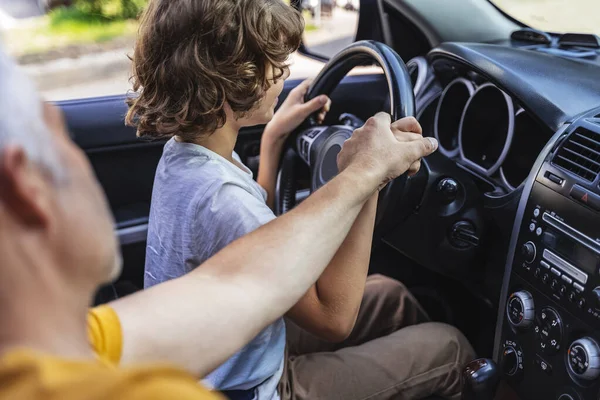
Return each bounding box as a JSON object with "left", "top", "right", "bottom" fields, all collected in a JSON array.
[{"left": 275, "top": 40, "right": 415, "bottom": 228}]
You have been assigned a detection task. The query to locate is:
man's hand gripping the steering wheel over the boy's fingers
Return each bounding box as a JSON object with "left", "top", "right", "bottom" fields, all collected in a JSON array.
[{"left": 338, "top": 113, "right": 438, "bottom": 188}]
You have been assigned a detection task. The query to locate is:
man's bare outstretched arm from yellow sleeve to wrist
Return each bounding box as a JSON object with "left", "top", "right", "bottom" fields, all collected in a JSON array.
[{"left": 111, "top": 166, "right": 376, "bottom": 377}]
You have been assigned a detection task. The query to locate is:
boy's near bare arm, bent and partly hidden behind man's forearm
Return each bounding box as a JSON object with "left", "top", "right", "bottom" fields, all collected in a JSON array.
[{"left": 287, "top": 118, "right": 422, "bottom": 342}]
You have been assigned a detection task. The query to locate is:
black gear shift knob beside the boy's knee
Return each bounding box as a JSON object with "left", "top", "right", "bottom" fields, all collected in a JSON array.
[{"left": 461, "top": 358, "right": 500, "bottom": 400}]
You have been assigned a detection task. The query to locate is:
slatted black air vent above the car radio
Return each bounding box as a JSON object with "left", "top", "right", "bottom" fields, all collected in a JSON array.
[{"left": 552, "top": 128, "right": 600, "bottom": 182}]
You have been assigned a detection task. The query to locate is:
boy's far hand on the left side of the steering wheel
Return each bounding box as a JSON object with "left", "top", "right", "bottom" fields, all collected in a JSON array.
[{"left": 263, "top": 79, "right": 331, "bottom": 142}]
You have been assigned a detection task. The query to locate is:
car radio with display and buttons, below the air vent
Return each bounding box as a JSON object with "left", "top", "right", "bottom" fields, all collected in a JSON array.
[{"left": 514, "top": 183, "right": 600, "bottom": 326}]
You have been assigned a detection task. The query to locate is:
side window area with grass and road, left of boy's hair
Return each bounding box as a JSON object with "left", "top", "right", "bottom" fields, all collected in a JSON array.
[{"left": 0, "top": 0, "right": 147, "bottom": 100}]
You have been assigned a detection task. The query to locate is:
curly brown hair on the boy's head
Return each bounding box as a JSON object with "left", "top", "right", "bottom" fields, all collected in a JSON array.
[{"left": 126, "top": 0, "right": 304, "bottom": 141}]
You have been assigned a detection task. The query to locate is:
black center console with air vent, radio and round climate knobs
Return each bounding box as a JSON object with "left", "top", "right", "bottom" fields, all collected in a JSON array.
[{"left": 494, "top": 115, "right": 600, "bottom": 400}]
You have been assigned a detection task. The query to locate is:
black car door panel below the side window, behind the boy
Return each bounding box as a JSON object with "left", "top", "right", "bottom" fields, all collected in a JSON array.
[{"left": 57, "top": 75, "right": 387, "bottom": 302}]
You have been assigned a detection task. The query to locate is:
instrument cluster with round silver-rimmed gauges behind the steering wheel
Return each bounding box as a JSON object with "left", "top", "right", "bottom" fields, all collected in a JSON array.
[{"left": 433, "top": 75, "right": 552, "bottom": 192}]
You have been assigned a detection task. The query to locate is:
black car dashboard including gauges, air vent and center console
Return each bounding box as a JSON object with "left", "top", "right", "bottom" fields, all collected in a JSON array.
[{"left": 386, "top": 43, "right": 600, "bottom": 400}]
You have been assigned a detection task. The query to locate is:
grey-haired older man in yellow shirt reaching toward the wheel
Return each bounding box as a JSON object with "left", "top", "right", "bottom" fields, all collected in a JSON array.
[{"left": 0, "top": 45, "right": 464, "bottom": 399}]
